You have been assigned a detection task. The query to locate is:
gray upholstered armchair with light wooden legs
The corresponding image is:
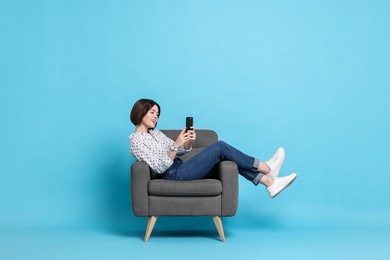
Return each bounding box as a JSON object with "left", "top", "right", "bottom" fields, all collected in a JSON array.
[{"left": 131, "top": 130, "right": 238, "bottom": 242}]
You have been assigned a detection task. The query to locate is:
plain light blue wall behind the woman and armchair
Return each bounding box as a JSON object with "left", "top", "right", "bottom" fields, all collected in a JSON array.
[{"left": 0, "top": 0, "right": 390, "bottom": 258}]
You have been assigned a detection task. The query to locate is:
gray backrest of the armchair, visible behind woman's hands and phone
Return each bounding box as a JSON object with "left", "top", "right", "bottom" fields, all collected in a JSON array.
[{"left": 161, "top": 129, "right": 218, "bottom": 161}]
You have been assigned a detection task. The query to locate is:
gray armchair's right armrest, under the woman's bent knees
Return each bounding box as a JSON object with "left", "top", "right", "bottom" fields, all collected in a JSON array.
[{"left": 218, "top": 161, "right": 238, "bottom": 216}]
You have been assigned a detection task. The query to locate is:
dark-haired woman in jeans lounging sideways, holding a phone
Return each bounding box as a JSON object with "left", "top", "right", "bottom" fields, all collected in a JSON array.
[{"left": 129, "top": 99, "right": 297, "bottom": 198}]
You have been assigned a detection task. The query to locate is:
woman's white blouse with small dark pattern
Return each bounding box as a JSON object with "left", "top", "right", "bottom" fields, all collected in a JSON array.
[{"left": 129, "top": 129, "right": 186, "bottom": 174}]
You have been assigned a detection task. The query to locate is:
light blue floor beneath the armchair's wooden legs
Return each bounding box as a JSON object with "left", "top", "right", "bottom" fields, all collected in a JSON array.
[{"left": 0, "top": 226, "right": 390, "bottom": 260}]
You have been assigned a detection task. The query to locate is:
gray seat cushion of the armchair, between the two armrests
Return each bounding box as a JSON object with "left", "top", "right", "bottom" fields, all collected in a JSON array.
[{"left": 148, "top": 179, "right": 222, "bottom": 197}]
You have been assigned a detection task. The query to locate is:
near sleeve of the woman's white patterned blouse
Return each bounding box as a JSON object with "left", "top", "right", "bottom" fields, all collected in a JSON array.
[{"left": 130, "top": 134, "right": 173, "bottom": 174}]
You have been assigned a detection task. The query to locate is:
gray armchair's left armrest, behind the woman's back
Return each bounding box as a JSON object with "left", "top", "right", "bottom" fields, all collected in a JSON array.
[{"left": 131, "top": 162, "right": 150, "bottom": 217}]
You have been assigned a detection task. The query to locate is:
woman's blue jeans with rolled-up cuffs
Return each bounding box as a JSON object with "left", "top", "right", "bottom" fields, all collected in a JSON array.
[{"left": 162, "top": 141, "right": 264, "bottom": 185}]
